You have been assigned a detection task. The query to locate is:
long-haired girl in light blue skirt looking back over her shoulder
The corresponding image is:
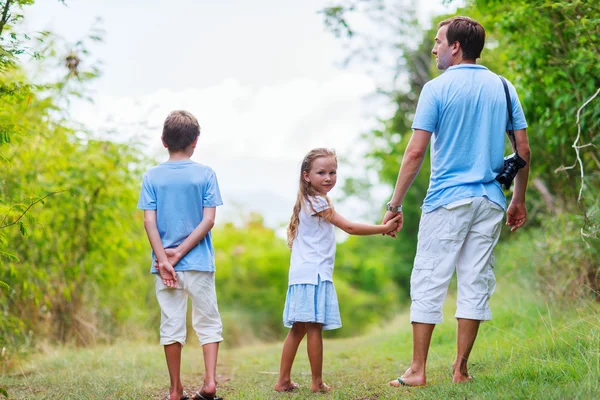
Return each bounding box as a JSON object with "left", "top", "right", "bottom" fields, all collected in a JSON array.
[{"left": 274, "top": 149, "right": 401, "bottom": 392}]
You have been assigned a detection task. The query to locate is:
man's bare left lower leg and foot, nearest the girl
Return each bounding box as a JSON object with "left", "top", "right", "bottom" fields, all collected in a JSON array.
[{"left": 389, "top": 322, "right": 435, "bottom": 387}]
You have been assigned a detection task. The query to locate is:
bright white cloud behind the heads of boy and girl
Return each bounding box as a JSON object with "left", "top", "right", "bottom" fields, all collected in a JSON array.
[{"left": 72, "top": 72, "right": 375, "bottom": 226}]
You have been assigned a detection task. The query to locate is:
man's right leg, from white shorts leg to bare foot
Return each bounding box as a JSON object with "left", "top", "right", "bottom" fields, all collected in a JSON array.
[{"left": 452, "top": 198, "right": 504, "bottom": 383}]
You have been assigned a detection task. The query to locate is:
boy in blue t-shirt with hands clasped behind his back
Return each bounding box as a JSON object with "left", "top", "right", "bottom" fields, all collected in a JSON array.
[{"left": 138, "top": 111, "right": 223, "bottom": 400}]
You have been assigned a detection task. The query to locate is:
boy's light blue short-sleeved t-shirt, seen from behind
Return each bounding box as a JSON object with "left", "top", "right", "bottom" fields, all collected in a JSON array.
[{"left": 138, "top": 160, "right": 223, "bottom": 273}]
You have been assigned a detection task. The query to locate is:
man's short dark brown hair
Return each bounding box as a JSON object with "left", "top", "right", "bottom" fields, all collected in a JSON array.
[{"left": 438, "top": 17, "right": 485, "bottom": 60}]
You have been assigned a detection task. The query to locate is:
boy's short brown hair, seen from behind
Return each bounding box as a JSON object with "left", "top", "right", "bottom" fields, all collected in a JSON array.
[{"left": 162, "top": 110, "right": 200, "bottom": 153}]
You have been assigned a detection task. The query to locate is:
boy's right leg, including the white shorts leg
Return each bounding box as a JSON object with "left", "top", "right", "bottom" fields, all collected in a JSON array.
[{"left": 183, "top": 271, "right": 223, "bottom": 398}]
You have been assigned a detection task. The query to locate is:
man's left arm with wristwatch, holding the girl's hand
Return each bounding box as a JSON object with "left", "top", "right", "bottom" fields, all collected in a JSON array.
[{"left": 382, "top": 129, "right": 431, "bottom": 236}]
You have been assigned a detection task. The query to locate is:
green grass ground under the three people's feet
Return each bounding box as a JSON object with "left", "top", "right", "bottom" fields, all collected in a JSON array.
[{"left": 0, "top": 233, "right": 600, "bottom": 400}]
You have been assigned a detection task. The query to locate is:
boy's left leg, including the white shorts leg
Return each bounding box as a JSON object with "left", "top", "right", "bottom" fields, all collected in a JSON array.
[{"left": 155, "top": 276, "right": 187, "bottom": 400}]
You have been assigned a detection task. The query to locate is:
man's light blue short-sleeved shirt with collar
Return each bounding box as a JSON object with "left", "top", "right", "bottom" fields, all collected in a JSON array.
[{"left": 412, "top": 64, "right": 527, "bottom": 212}]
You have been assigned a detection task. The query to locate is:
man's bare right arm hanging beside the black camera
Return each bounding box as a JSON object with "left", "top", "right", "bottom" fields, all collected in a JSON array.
[{"left": 506, "top": 129, "right": 531, "bottom": 232}]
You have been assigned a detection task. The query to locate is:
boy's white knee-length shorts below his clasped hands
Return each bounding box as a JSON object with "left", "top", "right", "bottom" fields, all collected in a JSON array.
[{"left": 155, "top": 271, "right": 223, "bottom": 345}]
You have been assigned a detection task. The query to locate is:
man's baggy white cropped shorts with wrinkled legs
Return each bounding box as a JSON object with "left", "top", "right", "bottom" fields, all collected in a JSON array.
[{"left": 410, "top": 197, "right": 504, "bottom": 324}]
